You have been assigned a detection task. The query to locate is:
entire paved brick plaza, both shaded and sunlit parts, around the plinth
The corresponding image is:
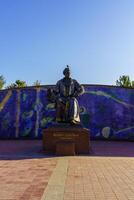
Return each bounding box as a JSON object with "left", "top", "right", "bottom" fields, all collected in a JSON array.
[{"left": 0, "top": 140, "right": 134, "bottom": 200}]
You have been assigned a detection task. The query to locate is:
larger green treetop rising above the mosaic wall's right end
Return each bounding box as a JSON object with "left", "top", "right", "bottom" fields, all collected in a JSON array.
[{"left": 116, "top": 75, "right": 133, "bottom": 87}]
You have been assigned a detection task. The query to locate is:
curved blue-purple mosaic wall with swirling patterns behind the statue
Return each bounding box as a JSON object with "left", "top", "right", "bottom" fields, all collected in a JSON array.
[{"left": 0, "top": 85, "right": 134, "bottom": 140}]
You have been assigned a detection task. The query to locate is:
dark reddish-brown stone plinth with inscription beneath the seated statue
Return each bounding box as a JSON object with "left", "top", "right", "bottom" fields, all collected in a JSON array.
[{"left": 43, "top": 125, "right": 90, "bottom": 155}]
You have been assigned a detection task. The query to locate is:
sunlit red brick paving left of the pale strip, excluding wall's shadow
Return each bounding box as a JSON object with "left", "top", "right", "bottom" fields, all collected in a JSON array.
[{"left": 0, "top": 158, "right": 57, "bottom": 200}]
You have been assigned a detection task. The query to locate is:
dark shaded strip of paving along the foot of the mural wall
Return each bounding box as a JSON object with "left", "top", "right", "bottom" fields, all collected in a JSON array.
[{"left": 0, "top": 140, "right": 134, "bottom": 160}]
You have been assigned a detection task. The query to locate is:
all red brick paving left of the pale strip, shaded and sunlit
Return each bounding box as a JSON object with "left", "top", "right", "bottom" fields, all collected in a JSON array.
[{"left": 0, "top": 140, "right": 57, "bottom": 200}]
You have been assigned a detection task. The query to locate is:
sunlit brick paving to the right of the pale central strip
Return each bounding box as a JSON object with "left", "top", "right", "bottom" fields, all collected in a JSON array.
[{"left": 64, "top": 157, "right": 134, "bottom": 200}]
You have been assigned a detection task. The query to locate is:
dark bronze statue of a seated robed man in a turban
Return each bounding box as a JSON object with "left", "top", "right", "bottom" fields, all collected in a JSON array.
[{"left": 47, "top": 65, "right": 84, "bottom": 124}]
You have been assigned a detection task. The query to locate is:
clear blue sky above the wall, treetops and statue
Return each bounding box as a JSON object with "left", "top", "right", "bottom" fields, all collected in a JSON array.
[{"left": 0, "top": 0, "right": 134, "bottom": 85}]
